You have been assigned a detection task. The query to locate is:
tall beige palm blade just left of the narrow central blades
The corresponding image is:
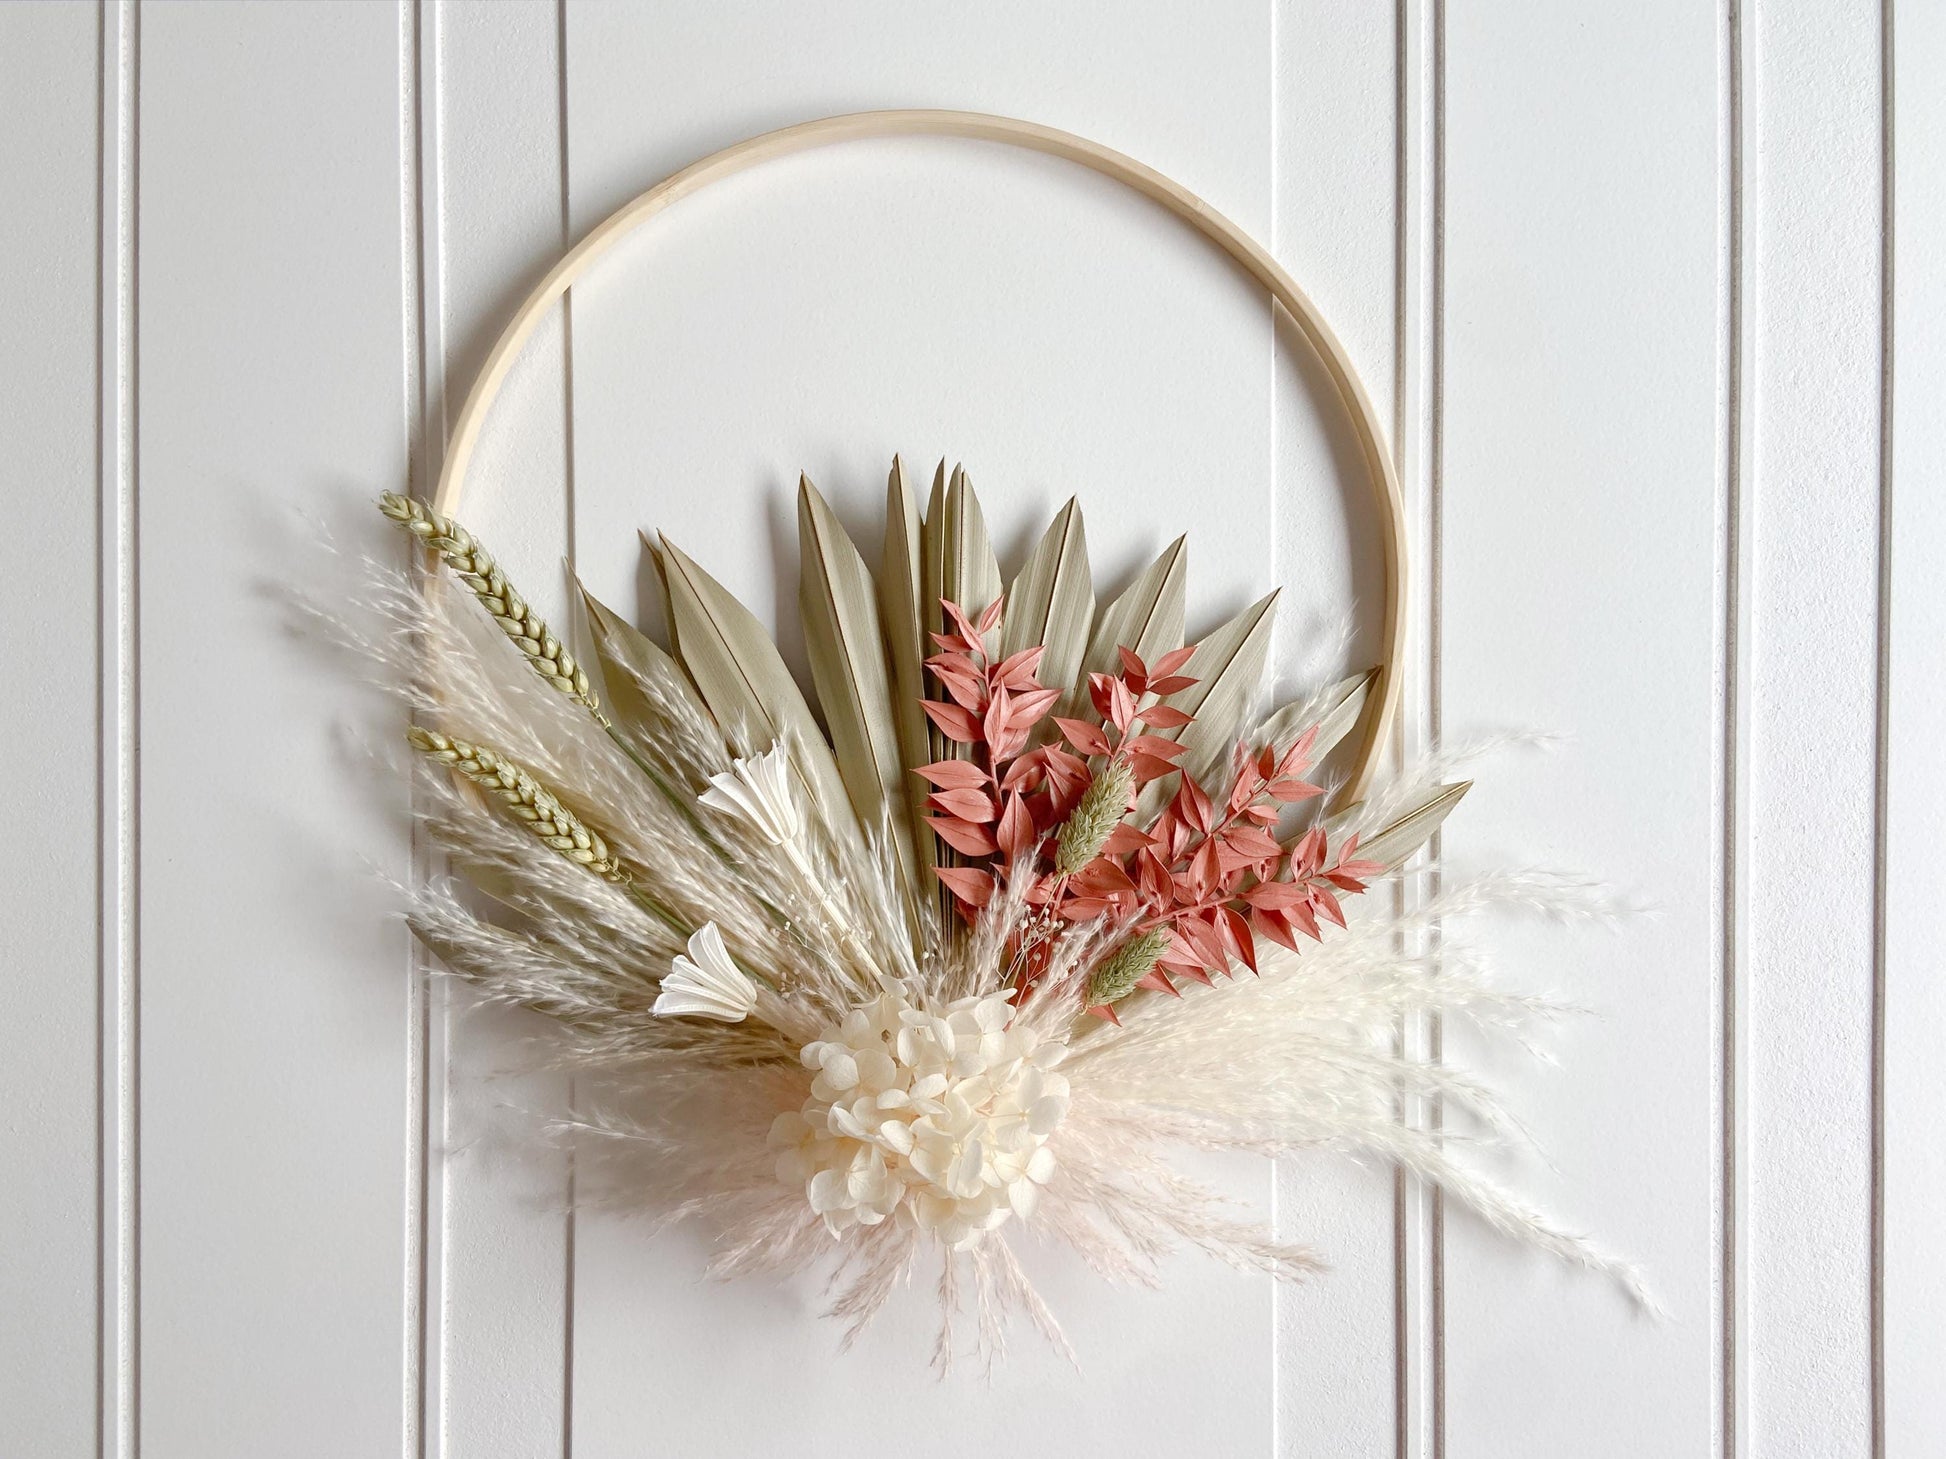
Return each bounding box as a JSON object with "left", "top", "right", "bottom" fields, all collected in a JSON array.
[{"left": 798, "top": 477, "right": 920, "bottom": 914}]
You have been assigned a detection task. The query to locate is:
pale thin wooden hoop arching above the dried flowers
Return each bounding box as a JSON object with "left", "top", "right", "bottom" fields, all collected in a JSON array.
[{"left": 432, "top": 111, "right": 1405, "bottom": 801}]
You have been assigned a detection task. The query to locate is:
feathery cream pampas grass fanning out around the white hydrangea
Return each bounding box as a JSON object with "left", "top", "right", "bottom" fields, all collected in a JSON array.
[{"left": 291, "top": 501, "right": 1650, "bottom": 1364}]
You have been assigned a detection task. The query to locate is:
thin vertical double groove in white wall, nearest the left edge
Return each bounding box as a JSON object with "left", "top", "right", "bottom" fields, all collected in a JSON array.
[{"left": 95, "top": 0, "right": 142, "bottom": 1459}]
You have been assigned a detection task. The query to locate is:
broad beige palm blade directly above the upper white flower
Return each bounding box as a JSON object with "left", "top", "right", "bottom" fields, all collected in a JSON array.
[{"left": 662, "top": 537, "right": 862, "bottom": 844}]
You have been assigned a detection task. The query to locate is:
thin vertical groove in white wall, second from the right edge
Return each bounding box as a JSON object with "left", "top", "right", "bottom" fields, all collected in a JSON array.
[{"left": 1716, "top": 0, "right": 1748, "bottom": 1459}]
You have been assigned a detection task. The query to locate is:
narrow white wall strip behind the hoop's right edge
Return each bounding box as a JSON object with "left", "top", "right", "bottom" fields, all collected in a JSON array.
[{"left": 1269, "top": 4, "right": 1405, "bottom": 1455}]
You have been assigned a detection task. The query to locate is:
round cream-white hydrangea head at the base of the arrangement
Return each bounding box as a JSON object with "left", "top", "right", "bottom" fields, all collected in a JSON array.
[{"left": 771, "top": 992, "right": 1068, "bottom": 1249}]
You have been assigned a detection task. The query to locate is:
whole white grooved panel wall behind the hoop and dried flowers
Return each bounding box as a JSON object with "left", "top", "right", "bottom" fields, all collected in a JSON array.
[{"left": 0, "top": 0, "right": 1946, "bottom": 1459}]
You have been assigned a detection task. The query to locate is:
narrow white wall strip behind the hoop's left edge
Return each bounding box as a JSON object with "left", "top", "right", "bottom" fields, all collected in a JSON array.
[{"left": 416, "top": 0, "right": 572, "bottom": 1455}]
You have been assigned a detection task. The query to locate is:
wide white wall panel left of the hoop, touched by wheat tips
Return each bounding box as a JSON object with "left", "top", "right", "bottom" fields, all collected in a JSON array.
[{"left": 136, "top": 4, "right": 413, "bottom": 1459}]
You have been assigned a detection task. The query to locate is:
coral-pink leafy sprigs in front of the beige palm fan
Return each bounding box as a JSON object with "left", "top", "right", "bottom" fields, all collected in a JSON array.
[{"left": 919, "top": 601, "right": 1382, "bottom": 1017}]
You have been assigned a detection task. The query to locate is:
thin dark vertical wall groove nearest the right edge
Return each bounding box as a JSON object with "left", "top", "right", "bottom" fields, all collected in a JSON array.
[{"left": 1870, "top": 0, "right": 1897, "bottom": 1459}]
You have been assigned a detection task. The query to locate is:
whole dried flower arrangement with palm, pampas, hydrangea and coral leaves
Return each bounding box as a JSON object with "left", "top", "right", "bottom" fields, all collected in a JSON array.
[{"left": 330, "top": 461, "right": 1640, "bottom": 1362}]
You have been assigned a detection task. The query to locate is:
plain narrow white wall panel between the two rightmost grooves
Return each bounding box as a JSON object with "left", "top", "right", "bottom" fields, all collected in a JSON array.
[{"left": 1746, "top": 2, "right": 1882, "bottom": 1459}]
